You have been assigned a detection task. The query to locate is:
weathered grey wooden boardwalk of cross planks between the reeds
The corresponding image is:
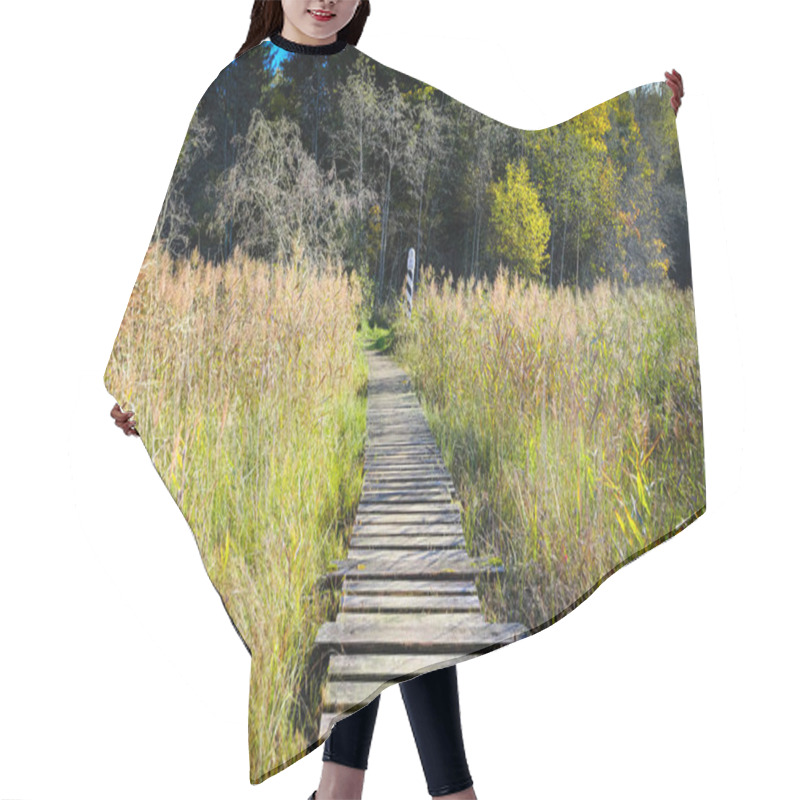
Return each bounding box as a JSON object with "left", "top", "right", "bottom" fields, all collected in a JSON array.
[{"left": 315, "top": 352, "right": 530, "bottom": 736}]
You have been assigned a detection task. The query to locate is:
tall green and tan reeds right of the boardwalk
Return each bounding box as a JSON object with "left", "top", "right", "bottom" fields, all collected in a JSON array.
[{"left": 393, "top": 268, "right": 705, "bottom": 630}]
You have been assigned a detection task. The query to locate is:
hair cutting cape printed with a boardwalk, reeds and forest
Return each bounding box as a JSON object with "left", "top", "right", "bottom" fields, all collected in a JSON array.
[{"left": 104, "top": 37, "right": 706, "bottom": 783}]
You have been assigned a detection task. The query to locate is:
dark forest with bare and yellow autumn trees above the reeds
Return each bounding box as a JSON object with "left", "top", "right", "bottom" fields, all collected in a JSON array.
[{"left": 153, "top": 47, "right": 691, "bottom": 298}]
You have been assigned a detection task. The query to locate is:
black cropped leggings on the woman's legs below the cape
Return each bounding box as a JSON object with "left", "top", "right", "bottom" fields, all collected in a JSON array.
[{"left": 322, "top": 664, "right": 472, "bottom": 797}]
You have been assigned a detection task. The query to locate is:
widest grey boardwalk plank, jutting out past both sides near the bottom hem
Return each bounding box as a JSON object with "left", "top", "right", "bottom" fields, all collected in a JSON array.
[{"left": 315, "top": 613, "right": 530, "bottom": 654}]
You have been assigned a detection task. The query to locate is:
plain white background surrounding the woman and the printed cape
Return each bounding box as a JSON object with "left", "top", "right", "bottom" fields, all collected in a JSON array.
[{"left": 0, "top": 0, "right": 799, "bottom": 800}]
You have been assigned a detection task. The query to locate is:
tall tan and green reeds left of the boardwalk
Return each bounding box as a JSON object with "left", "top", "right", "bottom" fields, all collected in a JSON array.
[{"left": 105, "top": 242, "right": 367, "bottom": 779}]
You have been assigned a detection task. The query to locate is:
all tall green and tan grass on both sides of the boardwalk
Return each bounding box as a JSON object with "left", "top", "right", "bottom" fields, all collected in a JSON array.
[{"left": 105, "top": 242, "right": 705, "bottom": 780}]
